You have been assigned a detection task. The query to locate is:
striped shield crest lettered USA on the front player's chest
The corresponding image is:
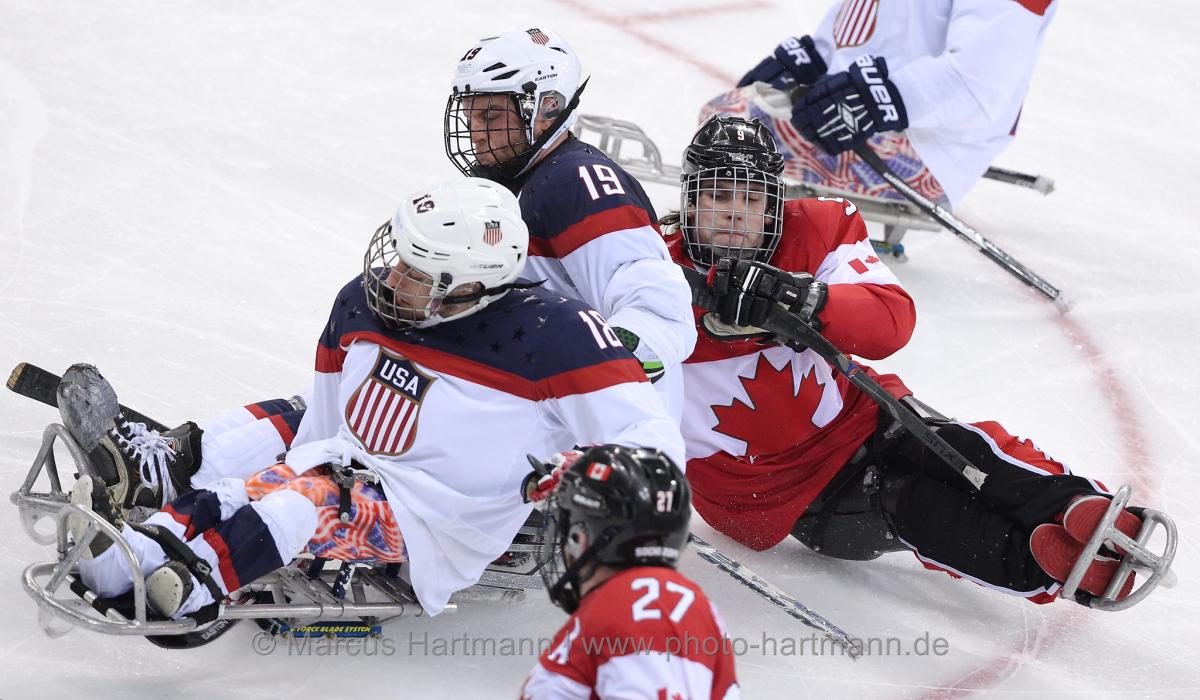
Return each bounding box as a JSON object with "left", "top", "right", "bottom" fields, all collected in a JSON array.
[{"left": 346, "top": 348, "right": 436, "bottom": 456}]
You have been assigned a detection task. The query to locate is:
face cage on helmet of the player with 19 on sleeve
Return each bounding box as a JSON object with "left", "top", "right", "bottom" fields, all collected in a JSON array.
[{"left": 444, "top": 90, "right": 535, "bottom": 183}]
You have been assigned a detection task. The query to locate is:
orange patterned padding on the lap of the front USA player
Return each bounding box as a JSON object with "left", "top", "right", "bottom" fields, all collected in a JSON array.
[{"left": 246, "top": 463, "right": 408, "bottom": 563}]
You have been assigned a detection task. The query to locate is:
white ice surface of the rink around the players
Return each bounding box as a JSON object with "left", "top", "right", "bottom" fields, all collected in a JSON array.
[{"left": 0, "top": 0, "right": 1200, "bottom": 700}]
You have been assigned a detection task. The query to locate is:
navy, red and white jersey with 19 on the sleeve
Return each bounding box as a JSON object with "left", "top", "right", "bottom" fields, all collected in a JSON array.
[{"left": 518, "top": 137, "right": 696, "bottom": 405}]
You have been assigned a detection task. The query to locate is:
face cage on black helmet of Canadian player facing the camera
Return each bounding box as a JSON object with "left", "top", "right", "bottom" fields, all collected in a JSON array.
[{"left": 679, "top": 167, "right": 784, "bottom": 267}]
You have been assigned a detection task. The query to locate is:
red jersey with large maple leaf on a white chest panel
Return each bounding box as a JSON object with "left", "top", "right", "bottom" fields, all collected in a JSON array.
[{"left": 667, "top": 198, "right": 917, "bottom": 550}]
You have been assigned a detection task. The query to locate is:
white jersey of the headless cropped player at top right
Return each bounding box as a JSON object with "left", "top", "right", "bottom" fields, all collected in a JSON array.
[{"left": 812, "top": 0, "right": 1057, "bottom": 202}]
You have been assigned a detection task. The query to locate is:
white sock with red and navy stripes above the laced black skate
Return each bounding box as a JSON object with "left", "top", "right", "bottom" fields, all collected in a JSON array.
[{"left": 192, "top": 401, "right": 304, "bottom": 489}]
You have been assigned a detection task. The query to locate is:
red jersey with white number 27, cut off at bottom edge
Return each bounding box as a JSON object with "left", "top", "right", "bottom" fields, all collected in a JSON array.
[{"left": 521, "top": 567, "right": 740, "bottom": 700}]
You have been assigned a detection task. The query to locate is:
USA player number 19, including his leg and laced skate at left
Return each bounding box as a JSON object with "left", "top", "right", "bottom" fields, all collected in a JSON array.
[{"left": 63, "top": 29, "right": 696, "bottom": 519}]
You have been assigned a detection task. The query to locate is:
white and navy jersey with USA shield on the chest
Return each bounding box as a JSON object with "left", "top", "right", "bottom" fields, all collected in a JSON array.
[{"left": 287, "top": 279, "right": 683, "bottom": 615}]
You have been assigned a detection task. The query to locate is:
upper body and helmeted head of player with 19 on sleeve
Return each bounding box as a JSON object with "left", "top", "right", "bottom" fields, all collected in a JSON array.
[{"left": 445, "top": 29, "right": 696, "bottom": 415}]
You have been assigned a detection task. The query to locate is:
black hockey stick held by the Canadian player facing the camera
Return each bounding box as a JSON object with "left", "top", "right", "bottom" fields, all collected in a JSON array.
[{"left": 683, "top": 267, "right": 988, "bottom": 491}]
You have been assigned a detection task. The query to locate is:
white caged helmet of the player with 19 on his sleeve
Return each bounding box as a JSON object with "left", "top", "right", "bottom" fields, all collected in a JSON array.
[{"left": 444, "top": 29, "right": 587, "bottom": 185}]
